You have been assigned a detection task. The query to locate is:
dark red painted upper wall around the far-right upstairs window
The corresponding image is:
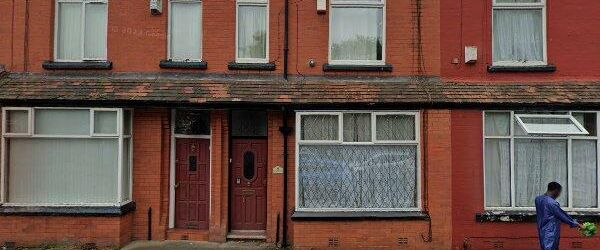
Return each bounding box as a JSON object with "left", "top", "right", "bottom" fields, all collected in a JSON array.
[{"left": 440, "top": 0, "right": 600, "bottom": 82}]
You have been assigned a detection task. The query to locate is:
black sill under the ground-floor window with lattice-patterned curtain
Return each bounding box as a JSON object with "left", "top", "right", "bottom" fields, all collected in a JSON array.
[{"left": 292, "top": 212, "right": 429, "bottom": 221}]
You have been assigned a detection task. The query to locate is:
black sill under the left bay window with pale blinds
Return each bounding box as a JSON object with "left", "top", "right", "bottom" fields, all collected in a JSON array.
[{"left": 0, "top": 202, "right": 135, "bottom": 217}]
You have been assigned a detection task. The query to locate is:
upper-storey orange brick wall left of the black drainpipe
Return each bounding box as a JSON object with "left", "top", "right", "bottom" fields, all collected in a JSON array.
[{"left": 0, "top": 0, "right": 283, "bottom": 73}]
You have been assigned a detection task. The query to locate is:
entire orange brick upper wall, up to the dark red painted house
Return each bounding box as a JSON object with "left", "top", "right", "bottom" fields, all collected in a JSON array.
[{"left": 0, "top": 0, "right": 440, "bottom": 76}]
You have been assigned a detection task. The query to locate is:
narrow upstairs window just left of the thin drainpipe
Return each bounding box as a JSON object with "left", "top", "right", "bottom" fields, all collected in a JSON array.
[{"left": 236, "top": 0, "right": 269, "bottom": 63}]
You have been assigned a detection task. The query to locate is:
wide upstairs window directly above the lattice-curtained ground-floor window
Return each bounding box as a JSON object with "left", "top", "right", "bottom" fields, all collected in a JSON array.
[{"left": 329, "top": 0, "right": 385, "bottom": 65}]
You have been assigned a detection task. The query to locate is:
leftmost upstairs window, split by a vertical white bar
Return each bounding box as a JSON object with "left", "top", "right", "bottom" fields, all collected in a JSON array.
[{"left": 55, "top": 0, "right": 108, "bottom": 62}]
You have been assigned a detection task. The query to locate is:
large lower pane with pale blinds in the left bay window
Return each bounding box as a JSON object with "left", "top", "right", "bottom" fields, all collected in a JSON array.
[{"left": 8, "top": 138, "right": 118, "bottom": 204}]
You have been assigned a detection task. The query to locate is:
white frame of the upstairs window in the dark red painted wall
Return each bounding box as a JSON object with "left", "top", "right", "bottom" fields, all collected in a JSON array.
[{"left": 491, "top": 0, "right": 548, "bottom": 66}]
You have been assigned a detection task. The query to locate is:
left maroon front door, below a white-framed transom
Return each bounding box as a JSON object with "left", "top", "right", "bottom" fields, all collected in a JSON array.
[{"left": 175, "top": 138, "right": 210, "bottom": 229}]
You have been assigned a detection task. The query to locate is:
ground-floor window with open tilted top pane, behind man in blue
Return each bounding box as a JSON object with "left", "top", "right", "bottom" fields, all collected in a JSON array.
[{"left": 484, "top": 111, "right": 599, "bottom": 210}]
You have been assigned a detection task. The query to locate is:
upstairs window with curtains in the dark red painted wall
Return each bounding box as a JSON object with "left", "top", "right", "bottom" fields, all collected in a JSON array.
[{"left": 493, "top": 0, "right": 547, "bottom": 66}]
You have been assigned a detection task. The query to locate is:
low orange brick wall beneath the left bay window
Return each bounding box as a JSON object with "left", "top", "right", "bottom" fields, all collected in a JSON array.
[{"left": 0, "top": 215, "right": 132, "bottom": 247}]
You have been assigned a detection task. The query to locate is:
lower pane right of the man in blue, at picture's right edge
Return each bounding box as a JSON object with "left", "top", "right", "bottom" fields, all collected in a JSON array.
[{"left": 571, "top": 140, "right": 598, "bottom": 208}]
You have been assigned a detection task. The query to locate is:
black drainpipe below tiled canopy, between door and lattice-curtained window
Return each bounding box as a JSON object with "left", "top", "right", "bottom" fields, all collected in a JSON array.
[{"left": 279, "top": 105, "right": 292, "bottom": 247}]
